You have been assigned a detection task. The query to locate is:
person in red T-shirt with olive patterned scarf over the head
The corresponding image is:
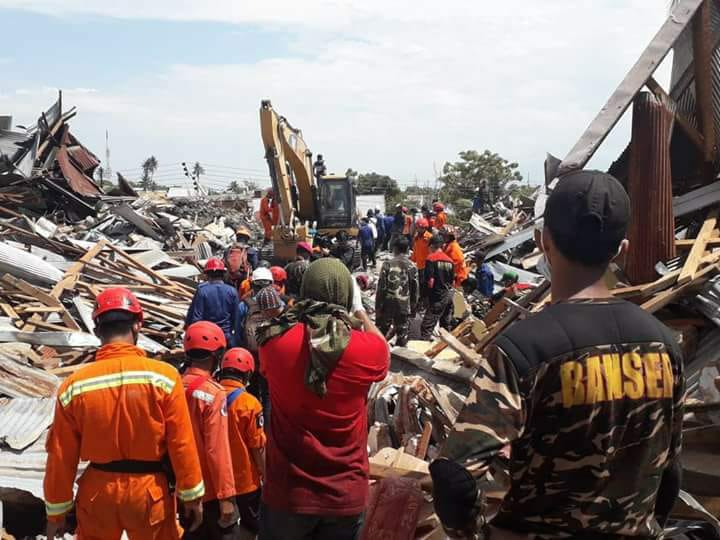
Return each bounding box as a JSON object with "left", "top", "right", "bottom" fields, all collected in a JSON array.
[{"left": 260, "top": 258, "right": 390, "bottom": 540}]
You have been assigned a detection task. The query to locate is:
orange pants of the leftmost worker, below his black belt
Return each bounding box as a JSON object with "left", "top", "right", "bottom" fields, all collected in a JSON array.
[{"left": 76, "top": 468, "right": 181, "bottom": 540}]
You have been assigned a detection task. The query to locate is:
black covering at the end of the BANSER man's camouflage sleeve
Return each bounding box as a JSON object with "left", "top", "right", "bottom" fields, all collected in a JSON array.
[{"left": 430, "top": 458, "right": 482, "bottom": 538}]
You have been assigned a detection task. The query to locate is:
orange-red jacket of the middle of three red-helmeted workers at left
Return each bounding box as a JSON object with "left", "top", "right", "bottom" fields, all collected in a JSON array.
[{"left": 182, "top": 367, "right": 235, "bottom": 502}]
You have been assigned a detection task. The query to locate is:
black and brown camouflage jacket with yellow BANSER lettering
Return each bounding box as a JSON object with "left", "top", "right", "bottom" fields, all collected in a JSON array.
[{"left": 443, "top": 300, "right": 684, "bottom": 539}]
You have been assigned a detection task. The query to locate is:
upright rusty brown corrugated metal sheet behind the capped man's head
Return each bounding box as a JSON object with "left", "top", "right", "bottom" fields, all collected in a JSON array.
[{"left": 625, "top": 93, "right": 675, "bottom": 283}]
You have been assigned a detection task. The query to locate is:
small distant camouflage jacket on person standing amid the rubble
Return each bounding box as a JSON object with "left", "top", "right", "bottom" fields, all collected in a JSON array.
[{"left": 375, "top": 255, "right": 420, "bottom": 317}]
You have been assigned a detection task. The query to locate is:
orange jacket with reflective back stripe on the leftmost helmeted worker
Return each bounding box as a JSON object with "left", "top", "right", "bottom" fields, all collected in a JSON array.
[{"left": 44, "top": 343, "right": 205, "bottom": 521}]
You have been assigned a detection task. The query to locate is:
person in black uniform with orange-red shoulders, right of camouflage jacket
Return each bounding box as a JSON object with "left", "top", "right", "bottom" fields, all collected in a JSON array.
[{"left": 420, "top": 235, "right": 455, "bottom": 340}]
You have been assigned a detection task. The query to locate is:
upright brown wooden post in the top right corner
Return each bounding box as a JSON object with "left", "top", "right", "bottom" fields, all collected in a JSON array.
[{"left": 693, "top": 0, "right": 715, "bottom": 169}]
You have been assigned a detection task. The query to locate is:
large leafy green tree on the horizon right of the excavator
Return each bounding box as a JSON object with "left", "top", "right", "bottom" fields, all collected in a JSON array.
[{"left": 440, "top": 150, "right": 522, "bottom": 208}]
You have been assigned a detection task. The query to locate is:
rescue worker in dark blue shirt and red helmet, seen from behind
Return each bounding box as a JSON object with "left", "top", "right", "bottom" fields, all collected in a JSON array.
[{"left": 185, "top": 258, "right": 240, "bottom": 343}]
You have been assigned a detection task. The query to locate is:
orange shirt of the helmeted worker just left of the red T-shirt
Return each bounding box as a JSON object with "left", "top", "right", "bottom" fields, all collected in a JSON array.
[{"left": 220, "top": 379, "right": 266, "bottom": 495}]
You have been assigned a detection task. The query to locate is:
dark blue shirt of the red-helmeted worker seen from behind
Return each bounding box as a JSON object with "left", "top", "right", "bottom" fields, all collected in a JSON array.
[{"left": 185, "top": 281, "right": 240, "bottom": 340}]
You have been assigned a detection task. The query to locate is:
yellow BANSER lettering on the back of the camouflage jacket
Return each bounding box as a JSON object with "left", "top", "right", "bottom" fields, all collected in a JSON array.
[{"left": 560, "top": 352, "right": 674, "bottom": 408}]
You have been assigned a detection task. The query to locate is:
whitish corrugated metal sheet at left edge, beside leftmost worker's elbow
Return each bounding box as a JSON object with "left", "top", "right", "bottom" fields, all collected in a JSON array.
[{"left": 0, "top": 398, "right": 55, "bottom": 450}]
